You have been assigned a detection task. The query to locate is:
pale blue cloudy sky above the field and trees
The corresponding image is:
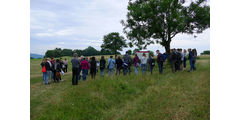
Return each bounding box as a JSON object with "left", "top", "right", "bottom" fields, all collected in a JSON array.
[{"left": 30, "top": 0, "right": 210, "bottom": 55}]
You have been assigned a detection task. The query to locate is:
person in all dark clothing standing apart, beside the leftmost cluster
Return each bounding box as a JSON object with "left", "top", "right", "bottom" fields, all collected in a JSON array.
[{"left": 71, "top": 53, "right": 80, "bottom": 85}]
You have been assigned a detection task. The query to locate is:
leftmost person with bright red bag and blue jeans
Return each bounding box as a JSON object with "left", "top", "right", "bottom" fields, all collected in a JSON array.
[{"left": 40, "top": 58, "right": 51, "bottom": 85}]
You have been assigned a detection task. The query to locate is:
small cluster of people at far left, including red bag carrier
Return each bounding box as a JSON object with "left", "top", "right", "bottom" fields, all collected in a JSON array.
[{"left": 41, "top": 58, "right": 68, "bottom": 85}]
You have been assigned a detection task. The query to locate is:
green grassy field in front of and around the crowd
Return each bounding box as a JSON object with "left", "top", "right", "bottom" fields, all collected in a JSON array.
[{"left": 30, "top": 56, "right": 210, "bottom": 120}]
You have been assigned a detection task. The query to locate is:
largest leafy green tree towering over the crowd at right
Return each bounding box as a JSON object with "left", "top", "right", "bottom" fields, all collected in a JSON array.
[{"left": 121, "top": 0, "right": 210, "bottom": 55}]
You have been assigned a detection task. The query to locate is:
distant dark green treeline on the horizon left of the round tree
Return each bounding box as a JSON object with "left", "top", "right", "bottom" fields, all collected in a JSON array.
[{"left": 45, "top": 46, "right": 120, "bottom": 57}]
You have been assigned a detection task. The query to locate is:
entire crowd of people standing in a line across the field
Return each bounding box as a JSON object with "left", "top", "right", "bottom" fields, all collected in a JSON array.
[{"left": 41, "top": 49, "right": 197, "bottom": 85}]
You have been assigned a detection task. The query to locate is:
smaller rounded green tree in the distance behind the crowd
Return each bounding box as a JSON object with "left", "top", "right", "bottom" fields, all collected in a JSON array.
[{"left": 101, "top": 32, "right": 127, "bottom": 58}]
